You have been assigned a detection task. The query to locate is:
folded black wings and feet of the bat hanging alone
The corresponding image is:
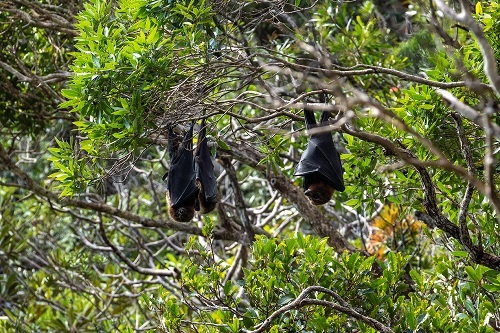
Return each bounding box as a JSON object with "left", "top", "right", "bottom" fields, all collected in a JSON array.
[{"left": 294, "top": 109, "right": 345, "bottom": 192}]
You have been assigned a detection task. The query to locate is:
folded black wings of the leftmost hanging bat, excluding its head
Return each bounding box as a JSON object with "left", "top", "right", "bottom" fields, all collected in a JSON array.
[{"left": 166, "top": 125, "right": 198, "bottom": 208}]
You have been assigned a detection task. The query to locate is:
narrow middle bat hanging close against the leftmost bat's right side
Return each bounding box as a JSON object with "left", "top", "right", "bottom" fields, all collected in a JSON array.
[{"left": 194, "top": 120, "right": 218, "bottom": 214}]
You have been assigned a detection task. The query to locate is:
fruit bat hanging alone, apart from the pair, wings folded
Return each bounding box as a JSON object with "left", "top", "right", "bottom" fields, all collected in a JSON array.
[{"left": 294, "top": 109, "right": 345, "bottom": 205}]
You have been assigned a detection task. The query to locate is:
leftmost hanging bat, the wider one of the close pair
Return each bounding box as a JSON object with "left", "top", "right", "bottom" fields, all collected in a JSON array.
[{"left": 163, "top": 124, "right": 198, "bottom": 222}]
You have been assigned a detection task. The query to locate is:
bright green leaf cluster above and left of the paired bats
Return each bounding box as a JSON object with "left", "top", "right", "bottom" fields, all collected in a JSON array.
[{"left": 52, "top": 0, "right": 218, "bottom": 195}]
